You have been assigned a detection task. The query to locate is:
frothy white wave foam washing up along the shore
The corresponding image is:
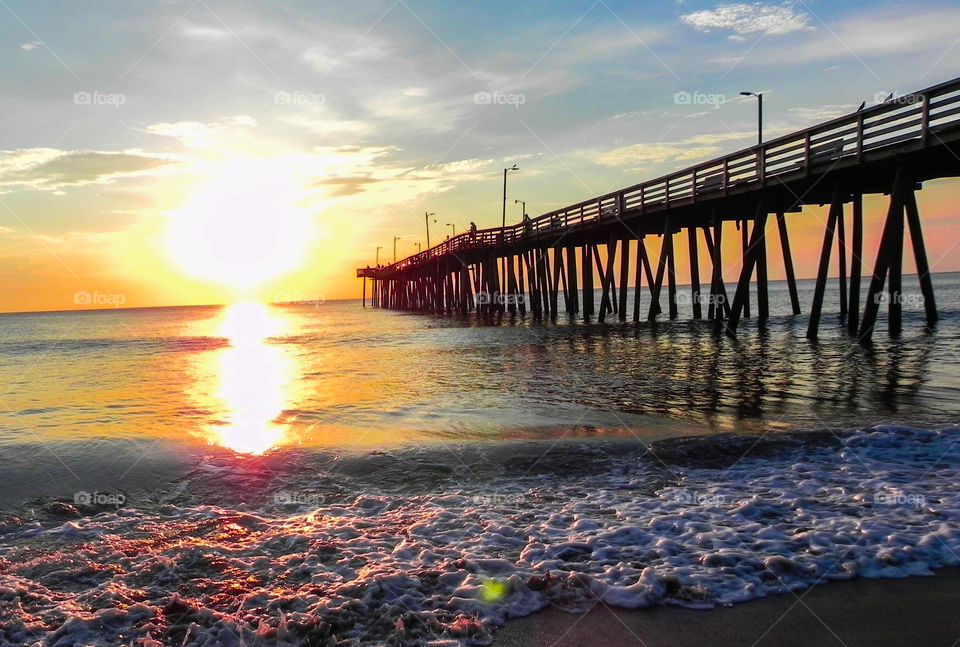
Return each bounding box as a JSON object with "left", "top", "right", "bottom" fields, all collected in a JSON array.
[{"left": 0, "top": 428, "right": 960, "bottom": 645}]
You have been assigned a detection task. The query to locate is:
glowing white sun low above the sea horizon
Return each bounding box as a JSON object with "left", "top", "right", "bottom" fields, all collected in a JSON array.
[{"left": 167, "top": 159, "right": 310, "bottom": 288}]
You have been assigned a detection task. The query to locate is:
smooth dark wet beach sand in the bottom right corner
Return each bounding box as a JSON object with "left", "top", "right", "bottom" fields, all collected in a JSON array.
[{"left": 493, "top": 567, "right": 960, "bottom": 647}]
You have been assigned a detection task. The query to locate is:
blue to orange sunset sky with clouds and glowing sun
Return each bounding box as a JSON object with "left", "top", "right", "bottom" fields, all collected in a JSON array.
[{"left": 0, "top": 0, "right": 960, "bottom": 312}]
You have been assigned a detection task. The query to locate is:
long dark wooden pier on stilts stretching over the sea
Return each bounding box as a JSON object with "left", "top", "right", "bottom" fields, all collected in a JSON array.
[{"left": 357, "top": 79, "right": 960, "bottom": 340}]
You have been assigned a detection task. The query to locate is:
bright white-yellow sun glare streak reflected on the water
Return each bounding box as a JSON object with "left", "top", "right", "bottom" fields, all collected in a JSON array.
[{"left": 210, "top": 303, "right": 291, "bottom": 454}]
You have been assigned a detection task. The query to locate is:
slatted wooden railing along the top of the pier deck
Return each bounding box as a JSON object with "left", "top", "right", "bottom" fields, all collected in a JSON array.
[{"left": 372, "top": 78, "right": 960, "bottom": 275}]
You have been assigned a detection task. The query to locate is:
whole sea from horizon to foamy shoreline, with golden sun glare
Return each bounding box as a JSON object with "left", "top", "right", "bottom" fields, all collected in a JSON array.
[{"left": 0, "top": 274, "right": 960, "bottom": 646}]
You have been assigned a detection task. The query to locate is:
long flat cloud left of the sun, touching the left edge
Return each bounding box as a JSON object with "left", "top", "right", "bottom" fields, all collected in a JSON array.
[{"left": 0, "top": 148, "right": 174, "bottom": 192}]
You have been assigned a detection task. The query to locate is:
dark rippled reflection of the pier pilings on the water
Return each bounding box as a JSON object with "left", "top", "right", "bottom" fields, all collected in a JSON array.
[{"left": 510, "top": 322, "right": 936, "bottom": 429}]
